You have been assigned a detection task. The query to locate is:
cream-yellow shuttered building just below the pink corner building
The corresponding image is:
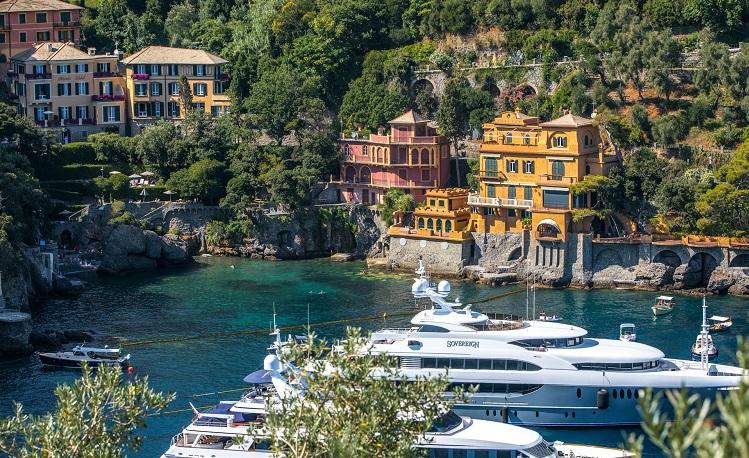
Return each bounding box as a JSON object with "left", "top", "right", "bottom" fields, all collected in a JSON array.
[{"left": 8, "top": 42, "right": 126, "bottom": 143}]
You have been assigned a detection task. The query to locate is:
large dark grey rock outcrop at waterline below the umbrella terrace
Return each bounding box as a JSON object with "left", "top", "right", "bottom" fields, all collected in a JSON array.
[{"left": 99, "top": 224, "right": 197, "bottom": 275}]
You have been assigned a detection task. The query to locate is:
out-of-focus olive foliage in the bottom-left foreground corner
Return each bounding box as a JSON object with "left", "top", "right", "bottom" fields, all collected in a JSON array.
[{"left": 0, "top": 367, "right": 174, "bottom": 458}]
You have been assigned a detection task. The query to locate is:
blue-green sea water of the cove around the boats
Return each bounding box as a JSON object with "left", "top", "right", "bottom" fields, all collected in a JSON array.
[{"left": 0, "top": 258, "right": 749, "bottom": 457}]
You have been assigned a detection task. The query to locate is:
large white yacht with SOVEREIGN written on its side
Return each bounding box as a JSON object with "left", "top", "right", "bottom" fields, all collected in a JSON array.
[{"left": 364, "top": 266, "right": 748, "bottom": 426}]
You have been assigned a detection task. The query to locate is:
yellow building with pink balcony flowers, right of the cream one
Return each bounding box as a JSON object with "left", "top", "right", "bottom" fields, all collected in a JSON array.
[{"left": 122, "top": 46, "right": 231, "bottom": 134}]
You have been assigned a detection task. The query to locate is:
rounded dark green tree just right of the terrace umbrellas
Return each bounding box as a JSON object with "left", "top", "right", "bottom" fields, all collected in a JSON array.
[{"left": 166, "top": 159, "right": 226, "bottom": 204}]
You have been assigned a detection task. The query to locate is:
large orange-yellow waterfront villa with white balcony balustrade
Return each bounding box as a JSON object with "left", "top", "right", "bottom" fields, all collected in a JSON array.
[{"left": 468, "top": 110, "right": 618, "bottom": 239}]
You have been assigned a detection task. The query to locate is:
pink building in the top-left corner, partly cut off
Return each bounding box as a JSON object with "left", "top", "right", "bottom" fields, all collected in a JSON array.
[{"left": 0, "top": 0, "right": 83, "bottom": 67}]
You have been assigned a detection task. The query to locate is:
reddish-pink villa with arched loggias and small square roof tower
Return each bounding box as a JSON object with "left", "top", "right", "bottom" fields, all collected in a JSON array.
[{"left": 338, "top": 110, "right": 450, "bottom": 204}]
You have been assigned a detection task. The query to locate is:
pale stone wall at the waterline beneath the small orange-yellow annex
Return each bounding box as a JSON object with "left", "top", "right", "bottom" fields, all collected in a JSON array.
[{"left": 387, "top": 237, "right": 473, "bottom": 275}]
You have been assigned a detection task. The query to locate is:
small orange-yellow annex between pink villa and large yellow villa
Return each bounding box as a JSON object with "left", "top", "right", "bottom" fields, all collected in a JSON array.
[{"left": 388, "top": 188, "right": 471, "bottom": 241}]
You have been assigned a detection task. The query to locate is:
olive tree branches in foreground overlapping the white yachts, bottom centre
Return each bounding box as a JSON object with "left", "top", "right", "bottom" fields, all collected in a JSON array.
[{"left": 267, "top": 329, "right": 461, "bottom": 458}]
